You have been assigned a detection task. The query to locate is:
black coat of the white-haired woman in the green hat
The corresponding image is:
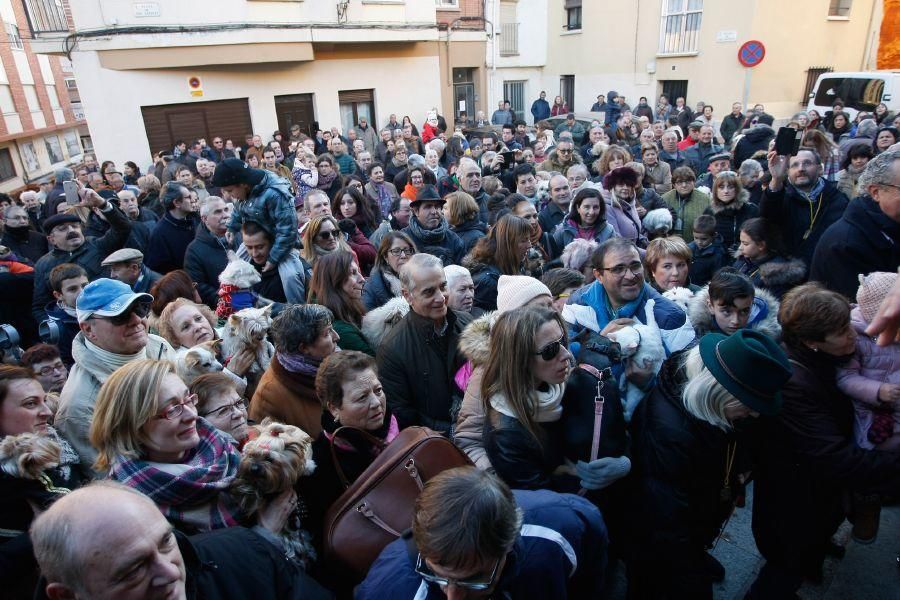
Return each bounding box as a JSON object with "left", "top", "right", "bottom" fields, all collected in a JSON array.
[{"left": 628, "top": 352, "right": 742, "bottom": 598}]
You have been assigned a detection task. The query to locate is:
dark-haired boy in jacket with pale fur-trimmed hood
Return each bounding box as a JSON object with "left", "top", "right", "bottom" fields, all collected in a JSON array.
[{"left": 688, "top": 267, "right": 781, "bottom": 341}]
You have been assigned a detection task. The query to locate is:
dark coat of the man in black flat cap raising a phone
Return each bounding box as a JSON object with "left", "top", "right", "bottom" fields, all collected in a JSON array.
[{"left": 31, "top": 207, "right": 131, "bottom": 323}]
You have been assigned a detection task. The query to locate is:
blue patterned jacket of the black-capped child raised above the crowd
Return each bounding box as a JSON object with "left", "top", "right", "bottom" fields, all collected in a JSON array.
[{"left": 228, "top": 171, "right": 298, "bottom": 264}]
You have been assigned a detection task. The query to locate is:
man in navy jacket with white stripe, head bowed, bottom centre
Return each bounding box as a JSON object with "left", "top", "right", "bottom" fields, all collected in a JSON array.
[{"left": 356, "top": 467, "right": 607, "bottom": 600}]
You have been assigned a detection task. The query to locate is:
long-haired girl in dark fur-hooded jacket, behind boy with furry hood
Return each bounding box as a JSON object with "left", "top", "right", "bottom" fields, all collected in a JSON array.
[{"left": 733, "top": 218, "right": 806, "bottom": 300}]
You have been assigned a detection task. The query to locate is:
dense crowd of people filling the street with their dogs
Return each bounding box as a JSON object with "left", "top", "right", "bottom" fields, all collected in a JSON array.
[{"left": 0, "top": 91, "right": 900, "bottom": 598}]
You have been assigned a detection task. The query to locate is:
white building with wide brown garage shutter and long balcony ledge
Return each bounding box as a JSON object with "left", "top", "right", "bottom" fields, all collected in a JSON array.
[{"left": 29, "top": 0, "right": 485, "bottom": 165}]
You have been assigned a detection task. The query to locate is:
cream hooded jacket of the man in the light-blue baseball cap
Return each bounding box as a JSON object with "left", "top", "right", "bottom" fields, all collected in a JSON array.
[{"left": 53, "top": 333, "right": 175, "bottom": 478}]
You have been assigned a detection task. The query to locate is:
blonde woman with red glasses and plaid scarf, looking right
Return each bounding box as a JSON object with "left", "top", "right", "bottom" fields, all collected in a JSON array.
[{"left": 91, "top": 360, "right": 295, "bottom": 533}]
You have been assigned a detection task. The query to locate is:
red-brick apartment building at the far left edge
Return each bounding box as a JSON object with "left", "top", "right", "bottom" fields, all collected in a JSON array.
[{"left": 0, "top": 0, "right": 90, "bottom": 193}]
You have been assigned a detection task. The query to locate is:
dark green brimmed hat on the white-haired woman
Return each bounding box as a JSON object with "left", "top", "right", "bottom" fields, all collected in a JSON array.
[{"left": 700, "top": 329, "right": 793, "bottom": 415}]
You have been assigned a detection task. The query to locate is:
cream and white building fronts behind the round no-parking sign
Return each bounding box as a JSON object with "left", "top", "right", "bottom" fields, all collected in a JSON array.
[{"left": 485, "top": 0, "right": 884, "bottom": 123}]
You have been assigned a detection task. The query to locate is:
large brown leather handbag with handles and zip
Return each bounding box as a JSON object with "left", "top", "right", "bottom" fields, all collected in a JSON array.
[{"left": 323, "top": 427, "right": 472, "bottom": 581}]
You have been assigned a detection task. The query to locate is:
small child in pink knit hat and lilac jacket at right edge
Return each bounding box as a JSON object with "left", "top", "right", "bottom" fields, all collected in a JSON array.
[{"left": 838, "top": 273, "right": 900, "bottom": 450}]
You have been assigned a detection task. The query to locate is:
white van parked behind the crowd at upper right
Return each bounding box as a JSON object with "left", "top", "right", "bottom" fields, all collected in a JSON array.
[{"left": 806, "top": 71, "right": 900, "bottom": 119}]
